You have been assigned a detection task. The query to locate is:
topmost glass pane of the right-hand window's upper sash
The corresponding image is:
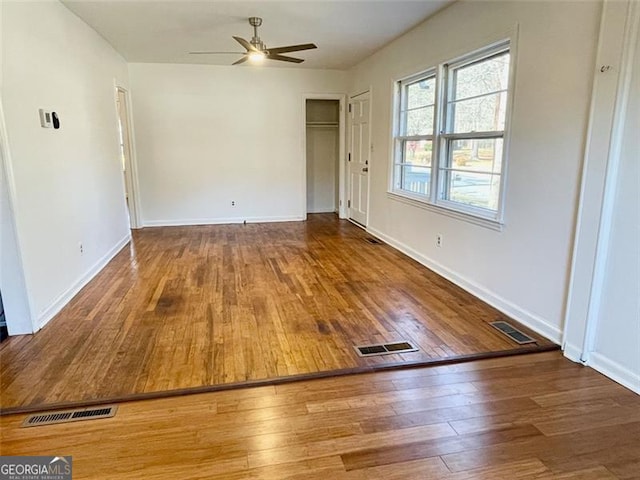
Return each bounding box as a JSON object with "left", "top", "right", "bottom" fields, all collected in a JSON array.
[{"left": 453, "top": 52, "right": 510, "bottom": 100}]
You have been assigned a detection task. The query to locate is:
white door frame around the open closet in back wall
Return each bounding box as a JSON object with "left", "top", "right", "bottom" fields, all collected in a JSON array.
[{"left": 301, "top": 93, "right": 347, "bottom": 220}]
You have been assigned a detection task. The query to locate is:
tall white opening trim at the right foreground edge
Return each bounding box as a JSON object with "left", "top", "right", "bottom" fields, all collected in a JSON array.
[{"left": 562, "top": 1, "right": 640, "bottom": 366}]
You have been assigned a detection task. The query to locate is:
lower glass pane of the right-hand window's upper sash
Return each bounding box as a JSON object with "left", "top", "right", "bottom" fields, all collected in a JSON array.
[{"left": 450, "top": 92, "right": 507, "bottom": 133}]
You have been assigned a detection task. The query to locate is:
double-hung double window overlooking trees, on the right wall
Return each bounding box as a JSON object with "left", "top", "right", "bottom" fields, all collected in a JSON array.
[{"left": 392, "top": 42, "right": 511, "bottom": 221}]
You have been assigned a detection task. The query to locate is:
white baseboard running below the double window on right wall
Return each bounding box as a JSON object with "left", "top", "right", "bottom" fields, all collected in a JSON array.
[{"left": 367, "top": 227, "right": 562, "bottom": 345}]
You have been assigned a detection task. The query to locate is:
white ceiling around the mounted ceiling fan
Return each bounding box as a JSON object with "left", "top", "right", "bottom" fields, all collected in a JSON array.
[{"left": 63, "top": 0, "right": 453, "bottom": 69}]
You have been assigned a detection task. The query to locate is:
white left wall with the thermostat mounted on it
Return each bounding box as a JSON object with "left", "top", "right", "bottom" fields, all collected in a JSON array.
[{"left": 2, "top": 2, "right": 129, "bottom": 328}]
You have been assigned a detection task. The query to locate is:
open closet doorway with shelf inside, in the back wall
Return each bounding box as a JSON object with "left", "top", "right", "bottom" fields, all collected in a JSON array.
[{"left": 305, "top": 99, "right": 340, "bottom": 213}]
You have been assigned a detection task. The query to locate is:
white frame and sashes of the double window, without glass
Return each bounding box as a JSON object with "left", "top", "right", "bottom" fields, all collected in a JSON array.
[{"left": 389, "top": 37, "right": 516, "bottom": 229}]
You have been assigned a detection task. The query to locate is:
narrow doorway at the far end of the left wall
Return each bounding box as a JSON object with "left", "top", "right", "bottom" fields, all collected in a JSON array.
[{"left": 116, "top": 87, "right": 139, "bottom": 228}]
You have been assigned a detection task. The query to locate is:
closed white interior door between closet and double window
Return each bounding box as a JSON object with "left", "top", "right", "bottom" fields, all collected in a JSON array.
[{"left": 347, "top": 92, "right": 371, "bottom": 226}]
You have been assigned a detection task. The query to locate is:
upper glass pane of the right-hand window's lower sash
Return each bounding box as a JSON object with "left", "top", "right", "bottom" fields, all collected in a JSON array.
[{"left": 448, "top": 138, "right": 504, "bottom": 174}]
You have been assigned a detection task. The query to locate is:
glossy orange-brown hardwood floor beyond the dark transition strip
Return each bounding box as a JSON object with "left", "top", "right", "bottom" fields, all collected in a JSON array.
[{"left": 0, "top": 215, "right": 553, "bottom": 413}]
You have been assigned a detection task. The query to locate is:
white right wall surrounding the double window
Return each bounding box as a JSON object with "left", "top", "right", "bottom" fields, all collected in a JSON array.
[{"left": 350, "top": 1, "right": 601, "bottom": 343}]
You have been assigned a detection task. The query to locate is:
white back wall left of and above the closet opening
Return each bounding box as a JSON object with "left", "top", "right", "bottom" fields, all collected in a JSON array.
[{"left": 129, "top": 64, "right": 346, "bottom": 225}]
